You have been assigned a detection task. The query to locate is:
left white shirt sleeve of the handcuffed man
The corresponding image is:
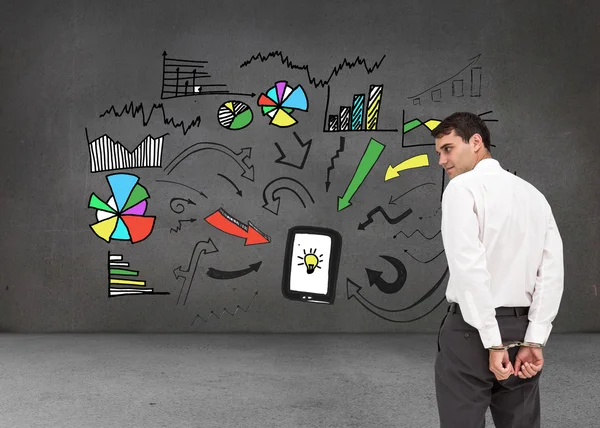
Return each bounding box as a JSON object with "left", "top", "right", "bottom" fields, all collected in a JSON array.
[{"left": 442, "top": 180, "right": 502, "bottom": 348}]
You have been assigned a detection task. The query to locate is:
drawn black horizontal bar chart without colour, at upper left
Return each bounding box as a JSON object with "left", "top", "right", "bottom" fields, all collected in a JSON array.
[{"left": 160, "top": 52, "right": 256, "bottom": 100}]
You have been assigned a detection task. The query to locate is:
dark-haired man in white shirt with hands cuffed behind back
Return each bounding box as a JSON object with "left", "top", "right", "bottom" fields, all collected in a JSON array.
[{"left": 432, "top": 113, "right": 564, "bottom": 428}]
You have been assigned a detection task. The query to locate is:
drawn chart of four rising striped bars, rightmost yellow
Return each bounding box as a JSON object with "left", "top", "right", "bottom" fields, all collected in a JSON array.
[{"left": 323, "top": 85, "right": 398, "bottom": 132}]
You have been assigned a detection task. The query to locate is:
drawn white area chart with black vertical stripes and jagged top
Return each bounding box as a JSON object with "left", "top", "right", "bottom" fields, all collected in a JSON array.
[{"left": 85, "top": 128, "right": 168, "bottom": 172}]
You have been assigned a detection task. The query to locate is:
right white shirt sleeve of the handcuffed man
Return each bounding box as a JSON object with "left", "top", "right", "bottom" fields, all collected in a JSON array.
[{"left": 525, "top": 205, "right": 564, "bottom": 346}]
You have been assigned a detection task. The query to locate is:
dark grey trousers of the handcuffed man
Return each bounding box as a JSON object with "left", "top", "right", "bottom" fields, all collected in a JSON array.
[{"left": 435, "top": 304, "right": 543, "bottom": 428}]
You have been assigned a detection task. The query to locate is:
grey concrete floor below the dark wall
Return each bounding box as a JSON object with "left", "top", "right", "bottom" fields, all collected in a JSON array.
[{"left": 0, "top": 334, "right": 600, "bottom": 428}]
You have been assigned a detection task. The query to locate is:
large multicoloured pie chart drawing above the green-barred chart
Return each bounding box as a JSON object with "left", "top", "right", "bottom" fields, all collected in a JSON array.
[{"left": 88, "top": 174, "right": 156, "bottom": 244}]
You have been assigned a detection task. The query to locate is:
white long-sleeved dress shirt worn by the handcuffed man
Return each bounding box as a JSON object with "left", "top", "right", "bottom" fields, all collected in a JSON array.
[{"left": 442, "top": 158, "right": 564, "bottom": 348}]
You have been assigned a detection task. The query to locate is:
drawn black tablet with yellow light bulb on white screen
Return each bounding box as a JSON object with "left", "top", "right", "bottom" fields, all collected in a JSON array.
[{"left": 282, "top": 226, "right": 342, "bottom": 304}]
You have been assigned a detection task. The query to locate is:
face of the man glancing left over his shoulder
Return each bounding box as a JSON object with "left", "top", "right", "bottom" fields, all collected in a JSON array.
[{"left": 435, "top": 130, "right": 476, "bottom": 180}]
